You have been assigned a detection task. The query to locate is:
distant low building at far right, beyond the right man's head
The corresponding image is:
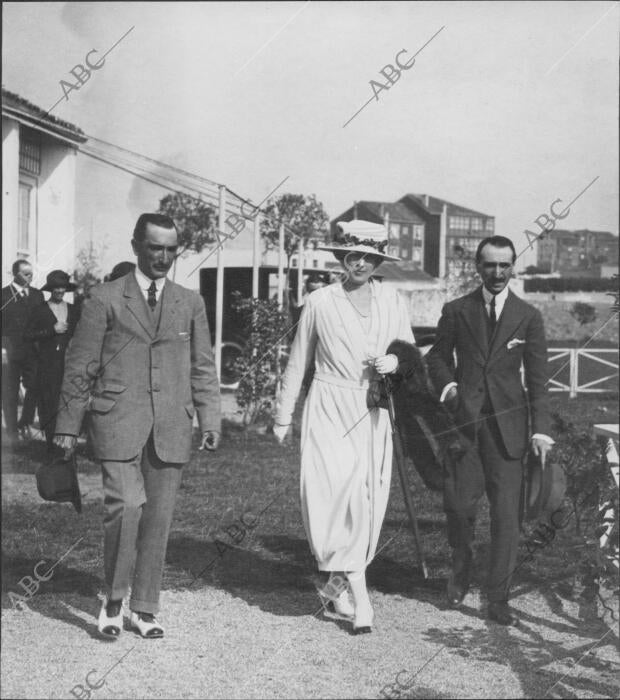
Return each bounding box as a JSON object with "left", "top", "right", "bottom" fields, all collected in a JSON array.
[{"left": 536, "top": 229, "right": 618, "bottom": 277}]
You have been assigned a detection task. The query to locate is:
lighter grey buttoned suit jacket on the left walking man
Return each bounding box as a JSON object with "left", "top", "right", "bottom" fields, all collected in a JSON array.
[{"left": 56, "top": 273, "right": 221, "bottom": 463}]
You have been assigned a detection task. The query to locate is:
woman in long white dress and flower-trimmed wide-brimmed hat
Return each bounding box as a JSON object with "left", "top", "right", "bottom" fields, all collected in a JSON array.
[{"left": 274, "top": 220, "right": 414, "bottom": 633}]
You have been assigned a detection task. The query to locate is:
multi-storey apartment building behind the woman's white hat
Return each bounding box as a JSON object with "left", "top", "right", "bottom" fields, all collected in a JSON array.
[{"left": 331, "top": 194, "right": 495, "bottom": 277}]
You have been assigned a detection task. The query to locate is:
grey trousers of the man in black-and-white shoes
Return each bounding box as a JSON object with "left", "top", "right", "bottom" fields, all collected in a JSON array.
[{"left": 101, "top": 433, "right": 183, "bottom": 614}]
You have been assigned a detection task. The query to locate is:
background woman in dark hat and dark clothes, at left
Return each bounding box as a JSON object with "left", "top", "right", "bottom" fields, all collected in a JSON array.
[{"left": 25, "top": 270, "right": 78, "bottom": 450}]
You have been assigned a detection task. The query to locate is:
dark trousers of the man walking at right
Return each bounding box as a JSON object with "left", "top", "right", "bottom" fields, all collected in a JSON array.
[{"left": 444, "top": 415, "right": 523, "bottom": 602}]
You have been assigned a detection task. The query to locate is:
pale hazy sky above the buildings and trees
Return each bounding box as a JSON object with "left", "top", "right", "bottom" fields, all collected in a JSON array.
[{"left": 2, "top": 1, "right": 620, "bottom": 271}]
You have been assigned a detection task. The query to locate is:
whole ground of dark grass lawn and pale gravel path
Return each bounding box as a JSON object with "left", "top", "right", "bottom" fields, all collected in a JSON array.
[{"left": 2, "top": 394, "right": 620, "bottom": 698}]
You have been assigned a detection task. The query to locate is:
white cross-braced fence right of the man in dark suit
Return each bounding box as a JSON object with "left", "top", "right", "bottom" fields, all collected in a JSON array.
[{"left": 549, "top": 348, "right": 618, "bottom": 398}]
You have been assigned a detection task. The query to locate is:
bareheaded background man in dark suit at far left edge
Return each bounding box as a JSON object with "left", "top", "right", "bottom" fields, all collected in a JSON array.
[{"left": 2, "top": 260, "right": 44, "bottom": 443}]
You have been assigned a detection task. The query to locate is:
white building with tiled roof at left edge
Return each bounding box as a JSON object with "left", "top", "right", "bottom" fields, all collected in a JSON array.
[{"left": 2, "top": 89, "right": 87, "bottom": 287}]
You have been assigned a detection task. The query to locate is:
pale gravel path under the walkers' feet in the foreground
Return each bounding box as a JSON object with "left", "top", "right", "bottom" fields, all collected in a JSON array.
[{"left": 2, "top": 582, "right": 620, "bottom": 698}]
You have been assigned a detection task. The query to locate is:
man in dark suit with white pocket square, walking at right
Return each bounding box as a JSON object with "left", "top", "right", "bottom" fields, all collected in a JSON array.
[{"left": 426, "top": 236, "right": 553, "bottom": 625}]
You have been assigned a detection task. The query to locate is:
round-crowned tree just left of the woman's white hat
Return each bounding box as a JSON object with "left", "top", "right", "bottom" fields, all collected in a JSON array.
[{"left": 261, "top": 194, "right": 329, "bottom": 276}]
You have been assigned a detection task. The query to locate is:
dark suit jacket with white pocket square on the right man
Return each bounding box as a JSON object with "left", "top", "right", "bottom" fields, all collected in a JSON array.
[{"left": 426, "top": 287, "right": 551, "bottom": 458}]
